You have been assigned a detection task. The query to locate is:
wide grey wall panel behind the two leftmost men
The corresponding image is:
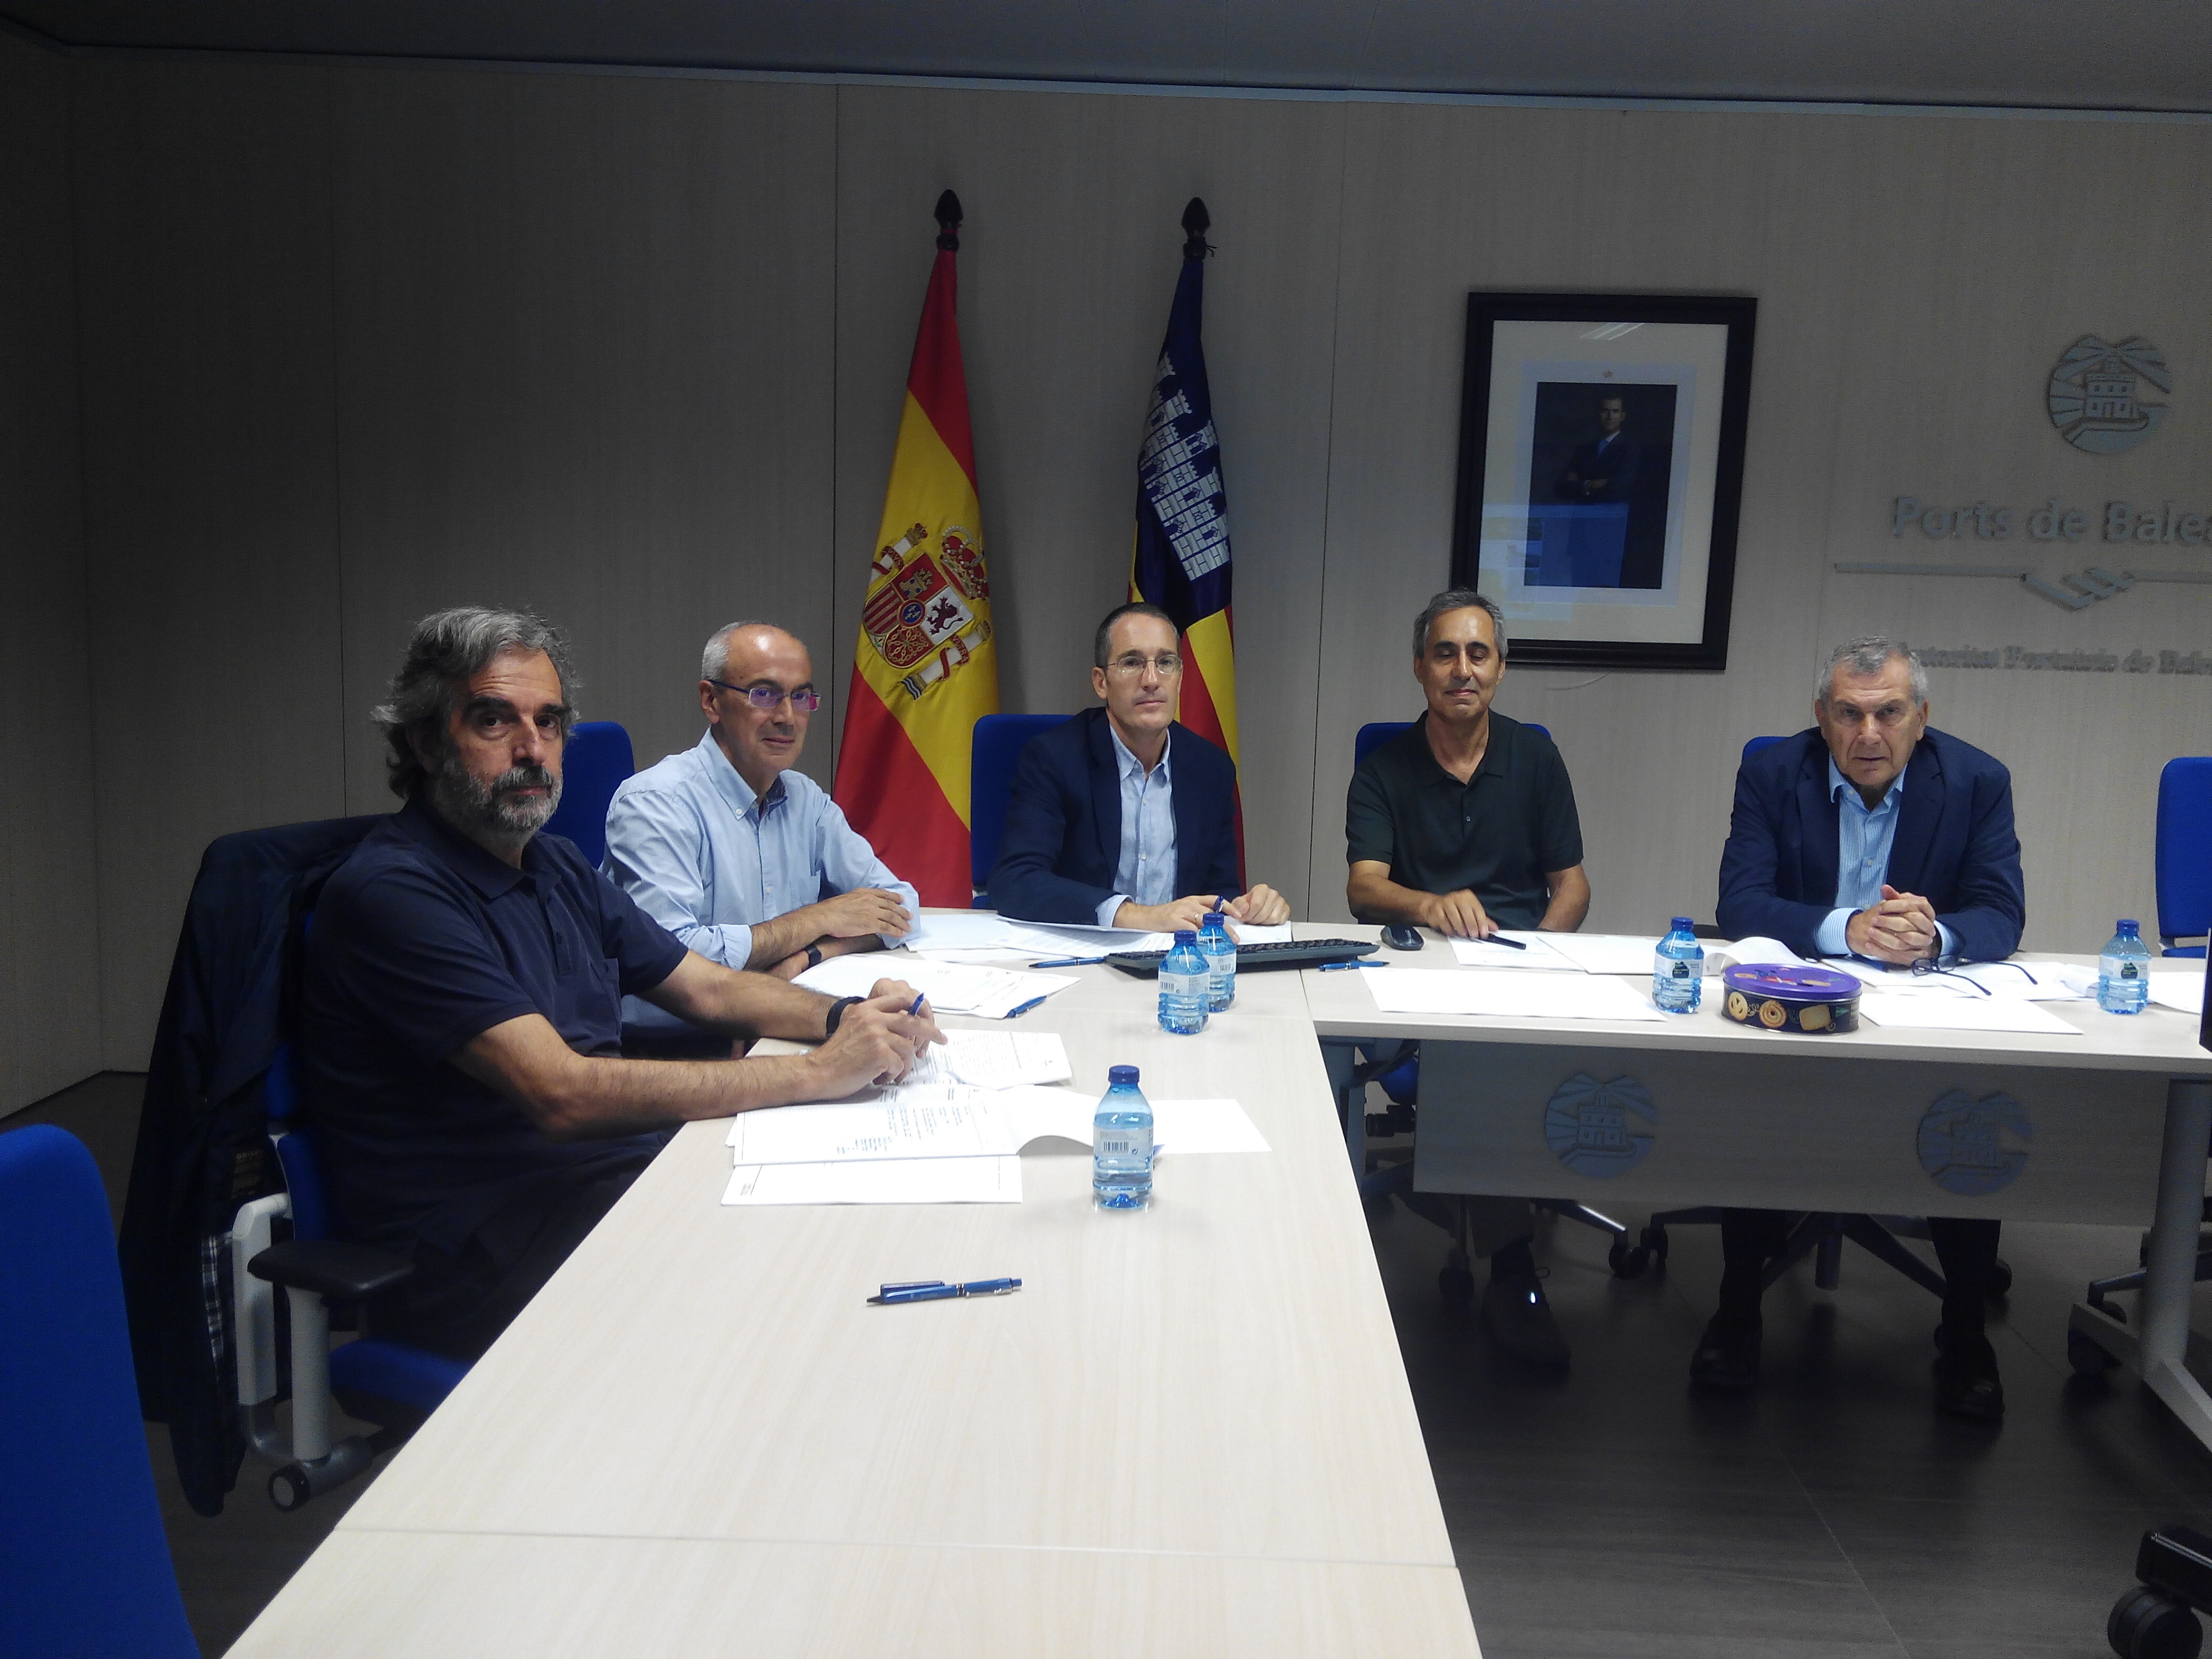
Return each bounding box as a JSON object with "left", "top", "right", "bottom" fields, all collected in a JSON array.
[{"left": 334, "top": 69, "right": 834, "bottom": 812}]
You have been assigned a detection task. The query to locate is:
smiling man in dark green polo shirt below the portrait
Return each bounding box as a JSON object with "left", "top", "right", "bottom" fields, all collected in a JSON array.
[{"left": 1345, "top": 589, "right": 1590, "bottom": 1367}]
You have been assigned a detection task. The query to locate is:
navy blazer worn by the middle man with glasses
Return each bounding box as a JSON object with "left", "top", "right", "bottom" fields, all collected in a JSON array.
[{"left": 991, "top": 708, "right": 1243, "bottom": 927}]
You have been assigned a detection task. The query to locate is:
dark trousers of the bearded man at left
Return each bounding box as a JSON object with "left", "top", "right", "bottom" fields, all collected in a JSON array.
[{"left": 369, "top": 1155, "right": 650, "bottom": 1361}]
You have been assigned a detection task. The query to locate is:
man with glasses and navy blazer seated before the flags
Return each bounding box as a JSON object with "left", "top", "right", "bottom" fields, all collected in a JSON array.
[{"left": 991, "top": 604, "right": 1290, "bottom": 931}]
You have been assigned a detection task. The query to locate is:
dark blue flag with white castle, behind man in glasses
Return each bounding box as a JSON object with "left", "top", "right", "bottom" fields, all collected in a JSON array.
[{"left": 1128, "top": 197, "right": 1243, "bottom": 865}]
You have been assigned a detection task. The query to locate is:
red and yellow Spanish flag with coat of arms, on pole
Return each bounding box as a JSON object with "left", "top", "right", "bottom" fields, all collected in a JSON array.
[{"left": 832, "top": 190, "right": 998, "bottom": 909}]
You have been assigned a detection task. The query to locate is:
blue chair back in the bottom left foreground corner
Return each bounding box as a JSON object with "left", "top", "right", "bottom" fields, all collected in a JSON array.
[{"left": 0, "top": 1124, "right": 199, "bottom": 1659}]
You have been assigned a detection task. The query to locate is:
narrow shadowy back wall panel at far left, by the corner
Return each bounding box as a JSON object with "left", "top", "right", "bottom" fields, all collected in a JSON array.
[{"left": 73, "top": 62, "right": 345, "bottom": 1068}]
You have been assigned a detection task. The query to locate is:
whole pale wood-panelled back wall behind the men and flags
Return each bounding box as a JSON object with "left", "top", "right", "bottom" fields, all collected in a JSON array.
[{"left": 56, "top": 62, "right": 2212, "bottom": 1066}]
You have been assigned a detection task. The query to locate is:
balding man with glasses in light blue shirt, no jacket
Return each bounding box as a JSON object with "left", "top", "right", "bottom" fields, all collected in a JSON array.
[{"left": 606, "top": 622, "right": 920, "bottom": 1031}]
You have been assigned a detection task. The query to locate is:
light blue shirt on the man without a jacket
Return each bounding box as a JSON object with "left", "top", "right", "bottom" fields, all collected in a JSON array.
[{"left": 606, "top": 730, "right": 922, "bottom": 1024}]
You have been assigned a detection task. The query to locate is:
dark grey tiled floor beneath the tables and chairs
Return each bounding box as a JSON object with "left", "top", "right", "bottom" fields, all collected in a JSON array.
[{"left": 0, "top": 1075, "right": 2212, "bottom": 1659}]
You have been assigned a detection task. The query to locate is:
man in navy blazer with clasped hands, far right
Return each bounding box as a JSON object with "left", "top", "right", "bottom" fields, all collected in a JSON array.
[{"left": 1690, "top": 637, "right": 2026, "bottom": 1420}]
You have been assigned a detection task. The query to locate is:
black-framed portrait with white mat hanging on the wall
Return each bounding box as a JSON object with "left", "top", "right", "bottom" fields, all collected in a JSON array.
[{"left": 1451, "top": 292, "right": 1758, "bottom": 668}]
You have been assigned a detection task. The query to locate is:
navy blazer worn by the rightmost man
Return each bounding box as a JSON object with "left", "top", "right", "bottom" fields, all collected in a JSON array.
[{"left": 1717, "top": 728, "right": 2028, "bottom": 962}]
